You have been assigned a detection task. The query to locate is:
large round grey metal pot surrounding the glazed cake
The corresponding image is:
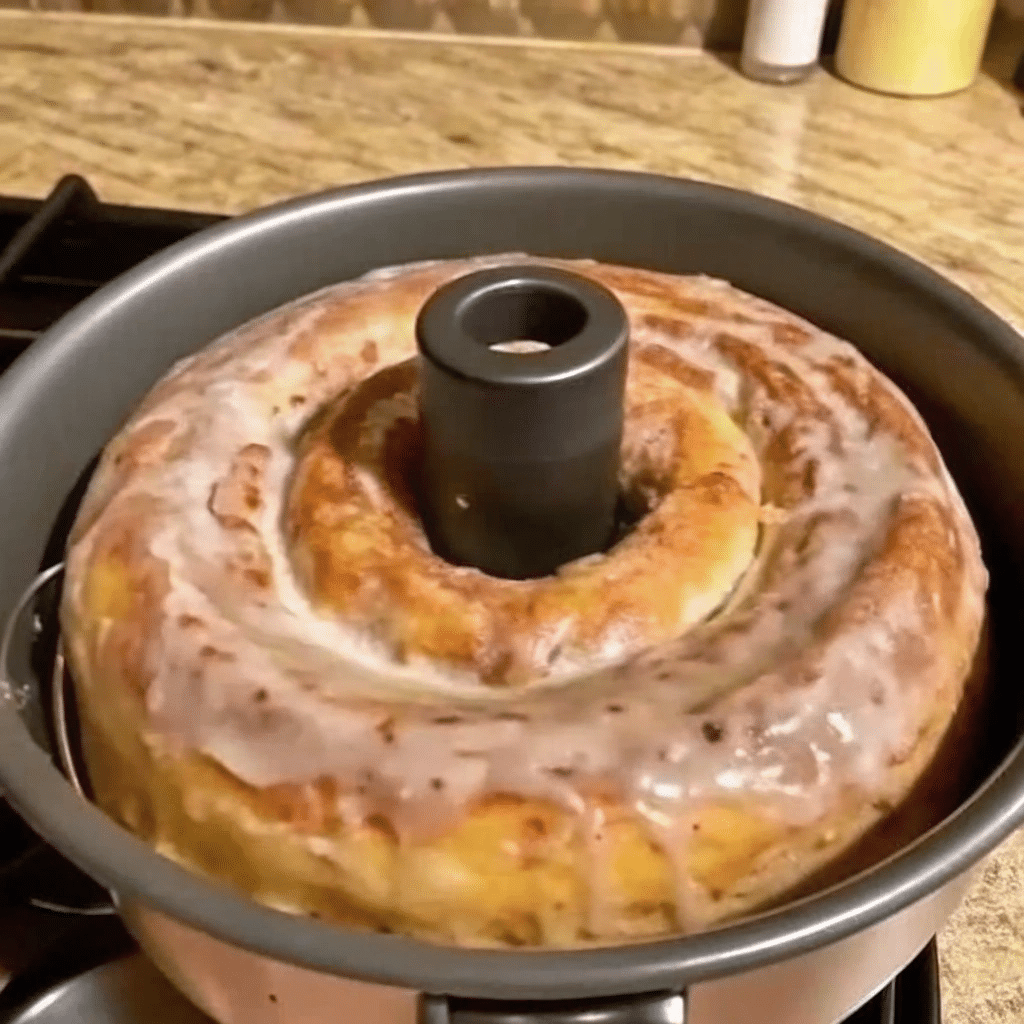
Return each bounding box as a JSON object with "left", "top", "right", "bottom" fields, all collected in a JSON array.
[{"left": 0, "top": 169, "right": 1024, "bottom": 1024}]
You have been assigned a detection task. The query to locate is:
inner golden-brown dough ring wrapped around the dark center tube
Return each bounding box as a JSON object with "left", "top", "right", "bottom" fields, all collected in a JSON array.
[{"left": 285, "top": 346, "right": 760, "bottom": 685}]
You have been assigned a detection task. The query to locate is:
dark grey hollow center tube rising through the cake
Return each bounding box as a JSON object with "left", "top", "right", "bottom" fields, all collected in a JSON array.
[{"left": 416, "top": 265, "right": 629, "bottom": 580}]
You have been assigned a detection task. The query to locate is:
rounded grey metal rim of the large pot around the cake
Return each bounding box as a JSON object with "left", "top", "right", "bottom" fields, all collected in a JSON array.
[{"left": 0, "top": 168, "right": 1024, "bottom": 998}]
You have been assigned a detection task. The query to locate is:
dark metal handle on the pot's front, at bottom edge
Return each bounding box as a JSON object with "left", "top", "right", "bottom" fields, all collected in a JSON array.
[{"left": 418, "top": 990, "right": 686, "bottom": 1024}]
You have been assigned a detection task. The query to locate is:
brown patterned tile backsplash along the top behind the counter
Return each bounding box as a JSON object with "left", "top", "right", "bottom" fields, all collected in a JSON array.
[{"left": 0, "top": 0, "right": 748, "bottom": 49}]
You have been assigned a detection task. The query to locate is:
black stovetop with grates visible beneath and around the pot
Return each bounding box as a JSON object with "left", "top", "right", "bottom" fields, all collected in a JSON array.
[{"left": 0, "top": 175, "right": 941, "bottom": 1024}]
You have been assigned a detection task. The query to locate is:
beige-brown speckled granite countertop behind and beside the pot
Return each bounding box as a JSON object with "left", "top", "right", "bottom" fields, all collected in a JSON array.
[{"left": 0, "top": 11, "right": 1024, "bottom": 1024}]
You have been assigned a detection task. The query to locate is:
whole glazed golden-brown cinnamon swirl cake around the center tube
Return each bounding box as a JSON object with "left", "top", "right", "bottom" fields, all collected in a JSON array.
[{"left": 61, "top": 257, "right": 987, "bottom": 947}]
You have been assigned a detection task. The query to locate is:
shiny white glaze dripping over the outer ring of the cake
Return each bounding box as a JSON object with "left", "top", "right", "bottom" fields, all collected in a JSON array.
[{"left": 63, "top": 257, "right": 987, "bottom": 934}]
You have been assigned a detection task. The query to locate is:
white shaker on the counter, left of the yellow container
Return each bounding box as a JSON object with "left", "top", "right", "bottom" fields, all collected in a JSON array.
[{"left": 739, "top": 0, "right": 828, "bottom": 85}]
